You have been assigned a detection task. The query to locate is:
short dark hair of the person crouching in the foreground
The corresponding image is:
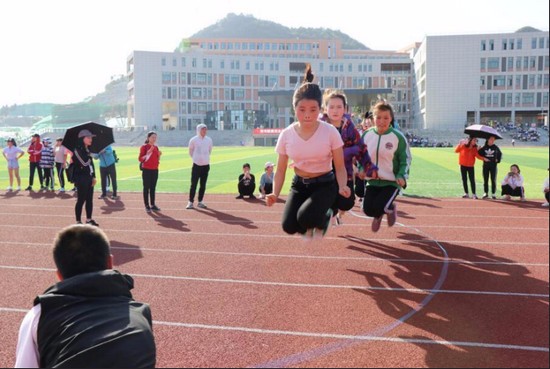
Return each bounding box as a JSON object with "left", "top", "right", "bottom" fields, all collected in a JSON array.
[{"left": 53, "top": 225, "right": 111, "bottom": 279}]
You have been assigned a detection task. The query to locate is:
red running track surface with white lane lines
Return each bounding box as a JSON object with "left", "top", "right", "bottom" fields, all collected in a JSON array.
[{"left": 0, "top": 194, "right": 549, "bottom": 367}]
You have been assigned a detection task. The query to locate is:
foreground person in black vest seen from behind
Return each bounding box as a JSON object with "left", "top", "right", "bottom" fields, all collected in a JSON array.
[{"left": 15, "top": 225, "right": 156, "bottom": 368}]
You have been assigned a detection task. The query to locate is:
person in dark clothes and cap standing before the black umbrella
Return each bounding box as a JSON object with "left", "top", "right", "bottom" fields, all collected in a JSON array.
[{"left": 72, "top": 129, "right": 99, "bottom": 227}]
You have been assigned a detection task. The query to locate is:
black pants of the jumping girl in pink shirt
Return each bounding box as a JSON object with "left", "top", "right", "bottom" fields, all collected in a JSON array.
[{"left": 283, "top": 177, "right": 338, "bottom": 234}]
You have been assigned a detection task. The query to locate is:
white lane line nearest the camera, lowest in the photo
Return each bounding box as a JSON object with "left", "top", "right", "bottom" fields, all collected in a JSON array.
[{"left": 0, "top": 307, "right": 549, "bottom": 352}]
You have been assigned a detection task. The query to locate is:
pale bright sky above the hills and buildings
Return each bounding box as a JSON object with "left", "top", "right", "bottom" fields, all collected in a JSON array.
[{"left": 0, "top": 0, "right": 549, "bottom": 106}]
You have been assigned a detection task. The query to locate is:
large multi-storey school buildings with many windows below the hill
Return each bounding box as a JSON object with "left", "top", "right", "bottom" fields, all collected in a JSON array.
[{"left": 127, "top": 28, "right": 549, "bottom": 137}]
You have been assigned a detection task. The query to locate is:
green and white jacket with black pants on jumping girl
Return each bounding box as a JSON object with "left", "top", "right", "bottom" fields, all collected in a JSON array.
[{"left": 363, "top": 127, "right": 412, "bottom": 218}]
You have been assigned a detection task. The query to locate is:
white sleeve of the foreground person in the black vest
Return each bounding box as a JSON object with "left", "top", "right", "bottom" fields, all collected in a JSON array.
[{"left": 15, "top": 304, "right": 42, "bottom": 368}]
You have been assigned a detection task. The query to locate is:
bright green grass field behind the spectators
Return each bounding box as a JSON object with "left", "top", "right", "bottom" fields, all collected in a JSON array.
[{"left": 0, "top": 147, "right": 549, "bottom": 199}]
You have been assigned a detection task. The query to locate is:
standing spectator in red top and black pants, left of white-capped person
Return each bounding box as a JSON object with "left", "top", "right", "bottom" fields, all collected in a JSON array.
[{"left": 138, "top": 131, "right": 162, "bottom": 213}]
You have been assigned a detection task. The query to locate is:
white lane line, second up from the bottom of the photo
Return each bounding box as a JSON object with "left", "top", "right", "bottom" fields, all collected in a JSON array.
[{"left": 0, "top": 265, "right": 550, "bottom": 298}]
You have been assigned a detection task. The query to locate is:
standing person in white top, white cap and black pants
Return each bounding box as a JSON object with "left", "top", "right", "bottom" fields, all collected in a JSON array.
[{"left": 186, "top": 124, "right": 213, "bottom": 209}]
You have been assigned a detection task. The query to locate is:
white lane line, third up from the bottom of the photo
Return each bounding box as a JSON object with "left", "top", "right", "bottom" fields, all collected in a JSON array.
[{"left": 0, "top": 241, "right": 550, "bottom": 268}]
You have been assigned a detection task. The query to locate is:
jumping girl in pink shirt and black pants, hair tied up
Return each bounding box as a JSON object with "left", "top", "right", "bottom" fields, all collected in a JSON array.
[{"left": 267, "top": 65, "right": 351, "bottom": 239}]
